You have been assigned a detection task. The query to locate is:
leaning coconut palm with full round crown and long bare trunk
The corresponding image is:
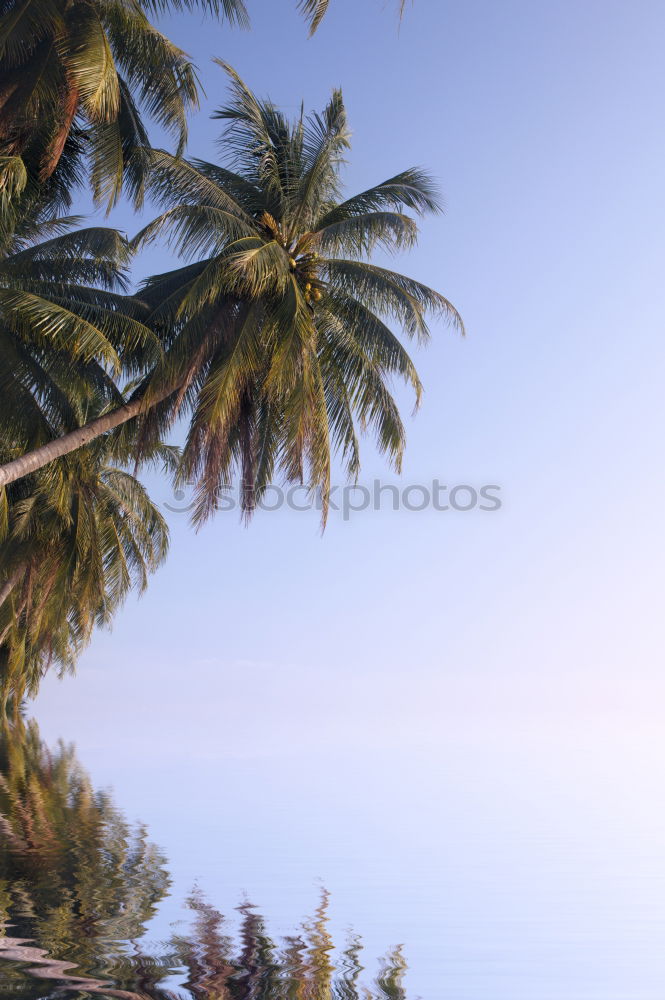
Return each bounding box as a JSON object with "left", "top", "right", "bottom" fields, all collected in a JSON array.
[{"left": 0, "top": 64, "right": 462, "bottom": 522}]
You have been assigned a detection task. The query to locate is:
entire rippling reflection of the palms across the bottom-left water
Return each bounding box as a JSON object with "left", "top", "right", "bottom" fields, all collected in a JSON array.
[{"left": 0, "top": 720, "right": 407, "bottom": 1000}]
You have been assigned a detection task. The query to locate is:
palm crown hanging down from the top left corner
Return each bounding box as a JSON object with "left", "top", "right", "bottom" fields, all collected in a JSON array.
[{"left": 0, "top": 0, "right": 390, "bottom": 208}]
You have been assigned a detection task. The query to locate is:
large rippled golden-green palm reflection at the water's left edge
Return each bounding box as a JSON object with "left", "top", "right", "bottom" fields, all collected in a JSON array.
[{"left": 0, "top": 719, "right": 169, "bottom": 988}]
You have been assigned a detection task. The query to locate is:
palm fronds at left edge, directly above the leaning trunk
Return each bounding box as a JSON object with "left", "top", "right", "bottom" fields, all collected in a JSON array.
[{"left": 0, "top": 203, "right": 159, "bottom": 458}]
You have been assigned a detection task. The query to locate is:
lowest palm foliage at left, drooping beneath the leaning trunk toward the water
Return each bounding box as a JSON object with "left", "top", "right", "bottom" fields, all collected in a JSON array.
[{"left": 0, "top": 430, "right": 176, "bottom": 710}]
